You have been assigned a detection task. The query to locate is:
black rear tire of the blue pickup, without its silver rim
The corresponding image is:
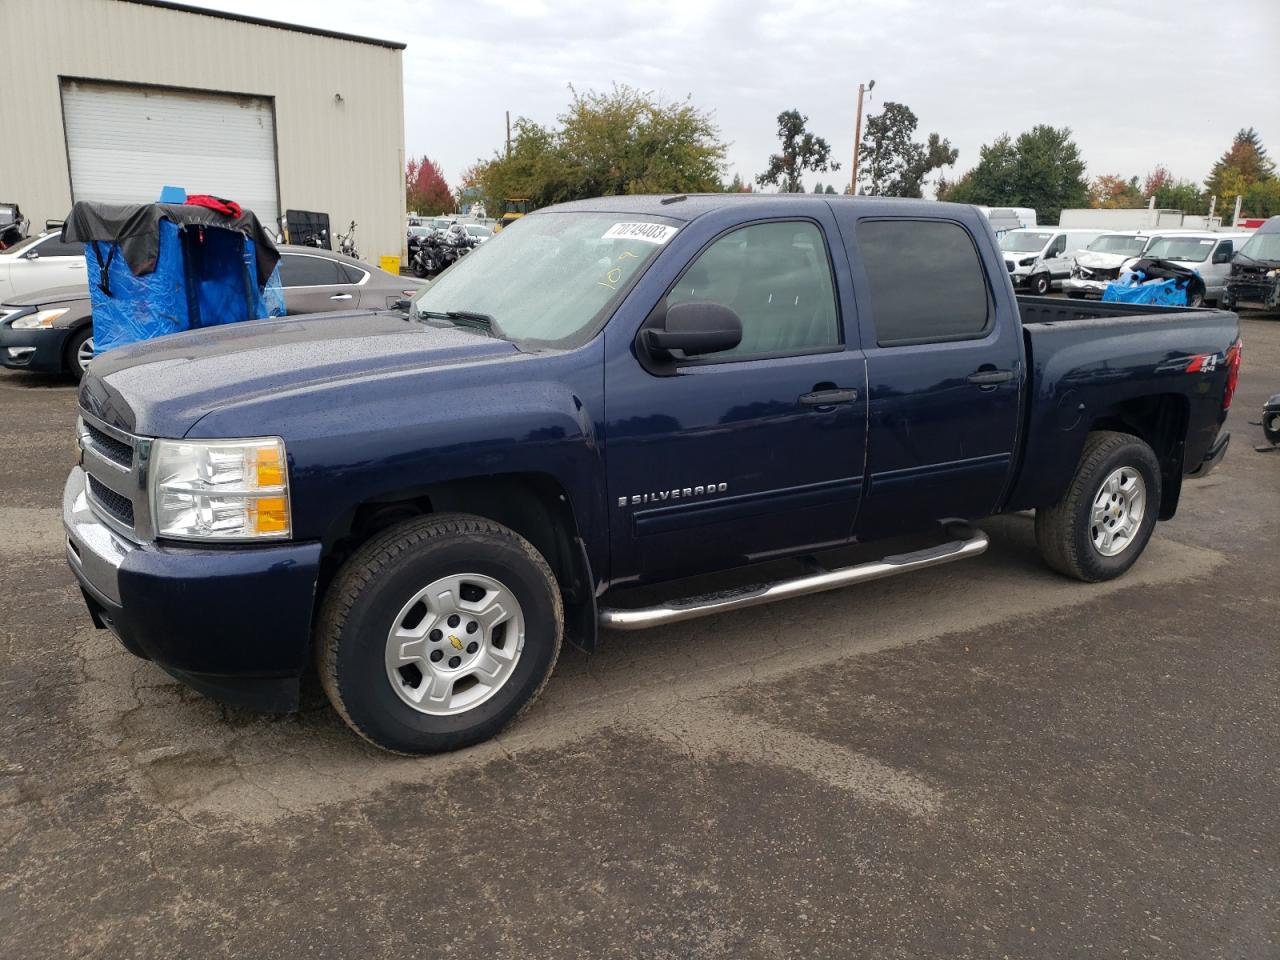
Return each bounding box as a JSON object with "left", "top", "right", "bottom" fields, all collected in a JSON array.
[{"left": 1036, "top": 430, "right": 1161, "bottom": 584}]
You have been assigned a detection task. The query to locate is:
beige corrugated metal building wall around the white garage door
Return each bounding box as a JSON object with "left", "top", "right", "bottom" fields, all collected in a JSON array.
[{"left": 0, "top": 0, "right": 404, "bottom": 264}]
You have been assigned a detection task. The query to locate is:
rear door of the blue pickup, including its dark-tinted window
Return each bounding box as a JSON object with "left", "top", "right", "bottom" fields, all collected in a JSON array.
[{"left": 841, "top": 213, "right": 1025, "bottom": 539}]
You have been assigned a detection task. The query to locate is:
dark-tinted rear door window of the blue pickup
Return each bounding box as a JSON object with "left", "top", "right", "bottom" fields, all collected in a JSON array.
[{"left": 858, "top": 220, "right": 991, "bottom": 347}]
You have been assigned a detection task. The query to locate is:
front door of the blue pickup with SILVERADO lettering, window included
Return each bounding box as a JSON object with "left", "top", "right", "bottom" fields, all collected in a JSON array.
[{"left": 605, "top": 215, "right": 867, "bottom": 584}]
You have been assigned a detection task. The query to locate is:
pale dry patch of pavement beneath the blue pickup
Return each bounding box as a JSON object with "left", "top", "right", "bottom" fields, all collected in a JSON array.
[{"left": 49, "top": 517, "right": 1225, "bottom": 826}]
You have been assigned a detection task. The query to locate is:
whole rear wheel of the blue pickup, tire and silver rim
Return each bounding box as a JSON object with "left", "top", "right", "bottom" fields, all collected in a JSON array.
[{"left": 1036, "top": 430, "right": 1161, "bottom": 582}]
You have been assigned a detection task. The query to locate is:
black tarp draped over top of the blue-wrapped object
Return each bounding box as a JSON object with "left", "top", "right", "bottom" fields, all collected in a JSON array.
[{"left": 63, "top": 200, "right": 280, "bottom": 287}]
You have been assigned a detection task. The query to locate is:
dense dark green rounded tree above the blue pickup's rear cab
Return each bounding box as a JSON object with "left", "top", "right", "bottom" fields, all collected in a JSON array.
[{"left": 938, "top": 124, "right": 1089, "bottom": 224}]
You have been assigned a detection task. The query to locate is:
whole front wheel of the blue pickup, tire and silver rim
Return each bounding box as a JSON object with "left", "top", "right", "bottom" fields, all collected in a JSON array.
[{"left": 315, "top": 513, "right": 564, "bottom": 754}]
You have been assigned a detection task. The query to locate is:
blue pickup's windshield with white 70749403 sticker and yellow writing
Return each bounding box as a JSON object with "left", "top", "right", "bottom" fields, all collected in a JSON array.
[{"left": 411, "top": 212, "right": 677, "bottom": 346}]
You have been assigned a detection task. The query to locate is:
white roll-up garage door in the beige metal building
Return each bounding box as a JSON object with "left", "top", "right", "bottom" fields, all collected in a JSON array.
[{"left": 63, "top": 81, "right": 280, "bottom": 225}]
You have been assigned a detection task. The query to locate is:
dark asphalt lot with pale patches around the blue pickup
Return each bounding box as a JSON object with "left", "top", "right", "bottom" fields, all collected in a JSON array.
[{"left": 0, "top": 312, "right": 1280, "bottom": 960}]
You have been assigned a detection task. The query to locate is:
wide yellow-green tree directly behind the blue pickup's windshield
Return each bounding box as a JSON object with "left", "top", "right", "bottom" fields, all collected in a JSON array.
[{"left": 476, "top": 84, "right": 741, "bottom": 210}]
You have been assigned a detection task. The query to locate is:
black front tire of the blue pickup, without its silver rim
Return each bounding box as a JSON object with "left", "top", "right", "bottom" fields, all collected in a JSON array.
[{"left": 315, "top": 513, "right": 564, "bottom": 754}]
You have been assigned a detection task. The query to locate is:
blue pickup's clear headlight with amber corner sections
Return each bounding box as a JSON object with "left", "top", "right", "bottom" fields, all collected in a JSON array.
[{"left": 148, "top": 436, "right": 291, "bottom": 540}]
